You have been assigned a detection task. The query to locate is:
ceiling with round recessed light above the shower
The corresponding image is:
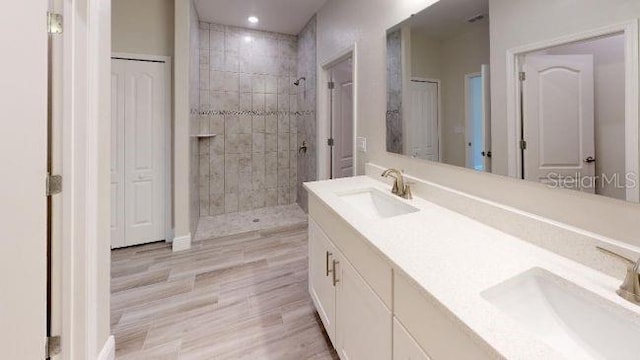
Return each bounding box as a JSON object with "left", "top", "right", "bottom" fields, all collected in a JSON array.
[{"left": 195, "top": 0, "right": 326, "bottom": 35}]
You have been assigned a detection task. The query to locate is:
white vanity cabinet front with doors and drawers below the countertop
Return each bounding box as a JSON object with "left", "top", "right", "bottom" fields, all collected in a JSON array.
[{"left": 309, "top": 196, "right": 488, "bottom": 360}]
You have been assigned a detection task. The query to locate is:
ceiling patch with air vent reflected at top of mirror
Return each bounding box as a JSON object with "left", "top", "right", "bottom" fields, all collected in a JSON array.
[{"left": 402, "top": 0, "right": 489, "bottom": 40}]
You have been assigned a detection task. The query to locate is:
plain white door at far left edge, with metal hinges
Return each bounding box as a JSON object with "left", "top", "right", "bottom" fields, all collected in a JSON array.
[{"left": 0, "top": 1, "right": 48, "bottom": 359}]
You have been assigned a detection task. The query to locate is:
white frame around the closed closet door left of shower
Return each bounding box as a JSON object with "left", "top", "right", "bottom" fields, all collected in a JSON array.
[{"left": 110, "top": 52, "right": 173, "bottom": 242}]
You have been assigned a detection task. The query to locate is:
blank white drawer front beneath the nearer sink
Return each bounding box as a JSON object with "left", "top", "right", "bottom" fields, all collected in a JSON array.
[{"left": 393, "top": 274, "right": 493, "bottom": 360}]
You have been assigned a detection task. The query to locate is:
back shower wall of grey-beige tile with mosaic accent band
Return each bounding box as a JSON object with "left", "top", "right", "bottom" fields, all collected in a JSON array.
[{"left": 199, "top": 23, "right": 297, "bottom": 216}]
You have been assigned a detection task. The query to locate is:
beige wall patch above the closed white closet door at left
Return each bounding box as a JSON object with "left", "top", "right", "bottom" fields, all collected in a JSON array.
[{"left": 111, "top": 0, "right": 174, "bottom": 56}]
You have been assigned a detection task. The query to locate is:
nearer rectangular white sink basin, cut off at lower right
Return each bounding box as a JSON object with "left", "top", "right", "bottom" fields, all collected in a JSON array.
[{"left": 482, "top": 268, "right": 640, "bottom": 360}]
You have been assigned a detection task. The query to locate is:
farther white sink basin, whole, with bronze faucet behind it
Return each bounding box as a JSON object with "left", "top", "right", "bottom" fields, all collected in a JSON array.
[{"left": 338, "top": 189, "right": 418, "bottom": 219}]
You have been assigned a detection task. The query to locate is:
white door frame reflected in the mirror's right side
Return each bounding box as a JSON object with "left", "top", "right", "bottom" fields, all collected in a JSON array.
[{"left": 506, "top": 19, "right": 640, "bottom": 202}]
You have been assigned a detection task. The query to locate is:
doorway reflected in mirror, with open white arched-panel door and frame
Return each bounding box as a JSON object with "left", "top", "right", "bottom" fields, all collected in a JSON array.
[{"left": 507, "top": 22, "right": 640, "bottom": 202}]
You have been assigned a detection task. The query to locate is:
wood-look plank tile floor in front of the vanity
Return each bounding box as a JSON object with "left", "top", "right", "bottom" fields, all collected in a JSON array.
[{"left": 111, "top": 223, "right": 337, "bottom": 360}]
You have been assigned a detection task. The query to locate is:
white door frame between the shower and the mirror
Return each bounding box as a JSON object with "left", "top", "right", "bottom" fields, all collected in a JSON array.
[{"left": 316, "top": 42, "right": 359, "bottom": 180}]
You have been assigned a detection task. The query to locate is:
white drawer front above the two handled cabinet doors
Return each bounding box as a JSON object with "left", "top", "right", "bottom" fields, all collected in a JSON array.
[{"left": 309, "top": 194, "right": 393, "bottom": 309}]
